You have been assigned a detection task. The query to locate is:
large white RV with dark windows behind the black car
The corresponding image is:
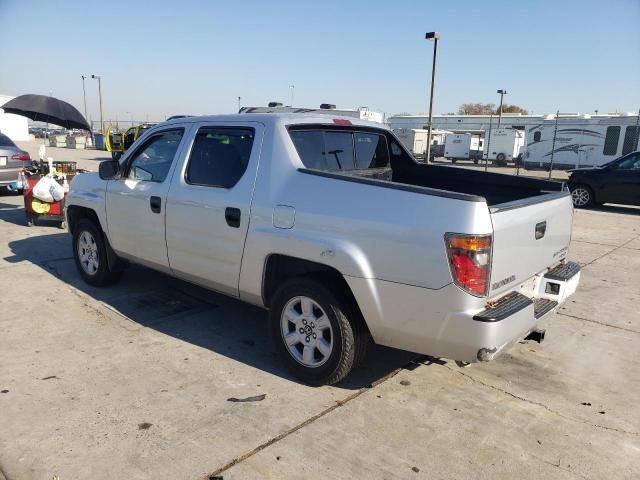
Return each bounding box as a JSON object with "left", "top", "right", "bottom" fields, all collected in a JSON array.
[{"left": 524, "top": 115, "right": 640, "bottom": 170}]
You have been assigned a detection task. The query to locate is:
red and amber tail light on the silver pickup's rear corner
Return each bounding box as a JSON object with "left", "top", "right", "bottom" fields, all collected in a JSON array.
[{"left": 445, "top": 233, "right": 491, "bottom": 296}]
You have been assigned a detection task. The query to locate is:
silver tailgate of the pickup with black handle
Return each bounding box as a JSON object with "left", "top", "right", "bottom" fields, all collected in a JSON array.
[{"left": 489, "top": 192, "right": 573, "bottom": 297}]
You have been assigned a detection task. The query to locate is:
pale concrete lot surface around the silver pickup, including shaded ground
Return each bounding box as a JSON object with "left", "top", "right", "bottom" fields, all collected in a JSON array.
[{"left": 0, "top": 142, "right": 640, "bottom": 480}]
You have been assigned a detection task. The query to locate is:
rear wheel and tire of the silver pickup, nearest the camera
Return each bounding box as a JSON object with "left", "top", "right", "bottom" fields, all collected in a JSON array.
[{"left": 269, "top": 277, "right": 370, "bottom": 385}]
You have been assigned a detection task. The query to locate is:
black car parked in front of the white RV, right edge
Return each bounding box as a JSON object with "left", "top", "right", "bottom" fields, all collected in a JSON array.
[{"left": 569, "top": 151, "right": 640, "bottom": 208}]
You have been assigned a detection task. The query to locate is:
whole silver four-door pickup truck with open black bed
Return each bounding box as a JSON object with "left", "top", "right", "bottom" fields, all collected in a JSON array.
[{"left": 66, "top": 113, "right": 580, "bottom": 384}]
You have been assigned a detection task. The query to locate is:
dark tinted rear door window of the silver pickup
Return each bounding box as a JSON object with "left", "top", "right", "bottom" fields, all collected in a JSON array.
[{"left": 185, "top": 127, "right": 255, "bottom": 188}]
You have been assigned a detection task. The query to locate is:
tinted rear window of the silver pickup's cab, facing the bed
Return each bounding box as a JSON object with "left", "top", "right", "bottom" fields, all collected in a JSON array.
[{"left": 290, "top": 130, "right": 389, "bottom": 171}]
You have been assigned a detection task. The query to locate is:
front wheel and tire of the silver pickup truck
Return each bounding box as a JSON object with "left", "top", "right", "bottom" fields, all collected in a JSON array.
[{"left": 73, "top": 218, "right": 122, "bottom": 287}]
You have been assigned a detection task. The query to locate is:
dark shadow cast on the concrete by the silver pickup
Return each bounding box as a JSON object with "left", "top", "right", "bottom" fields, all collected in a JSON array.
[{"left": 5, "top": 232, "right": 417, "bottom": 389}]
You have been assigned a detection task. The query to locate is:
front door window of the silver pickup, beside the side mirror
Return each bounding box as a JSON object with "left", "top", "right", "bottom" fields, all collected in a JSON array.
[{"left": 127, "top": 129, "right": 184, "bottom": 183}]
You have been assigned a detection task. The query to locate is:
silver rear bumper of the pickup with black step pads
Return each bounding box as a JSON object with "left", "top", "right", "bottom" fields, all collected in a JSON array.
[{"left": 347, "top": 264, "right": 580, "bottom": 363}]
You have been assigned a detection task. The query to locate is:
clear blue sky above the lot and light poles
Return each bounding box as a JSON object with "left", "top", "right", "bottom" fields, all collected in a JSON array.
[{"left": 0, "top": 0, "right": 640, "bottom": 120}]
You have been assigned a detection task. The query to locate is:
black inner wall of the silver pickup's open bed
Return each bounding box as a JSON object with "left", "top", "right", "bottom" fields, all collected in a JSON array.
[{"left": 391, "top": 160, "right": 563, "bottom": 206}]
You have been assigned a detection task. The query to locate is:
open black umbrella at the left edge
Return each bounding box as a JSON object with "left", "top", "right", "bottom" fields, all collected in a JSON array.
[{"left": 0, "top": 95, "right": 91, "bottom": 132}]
